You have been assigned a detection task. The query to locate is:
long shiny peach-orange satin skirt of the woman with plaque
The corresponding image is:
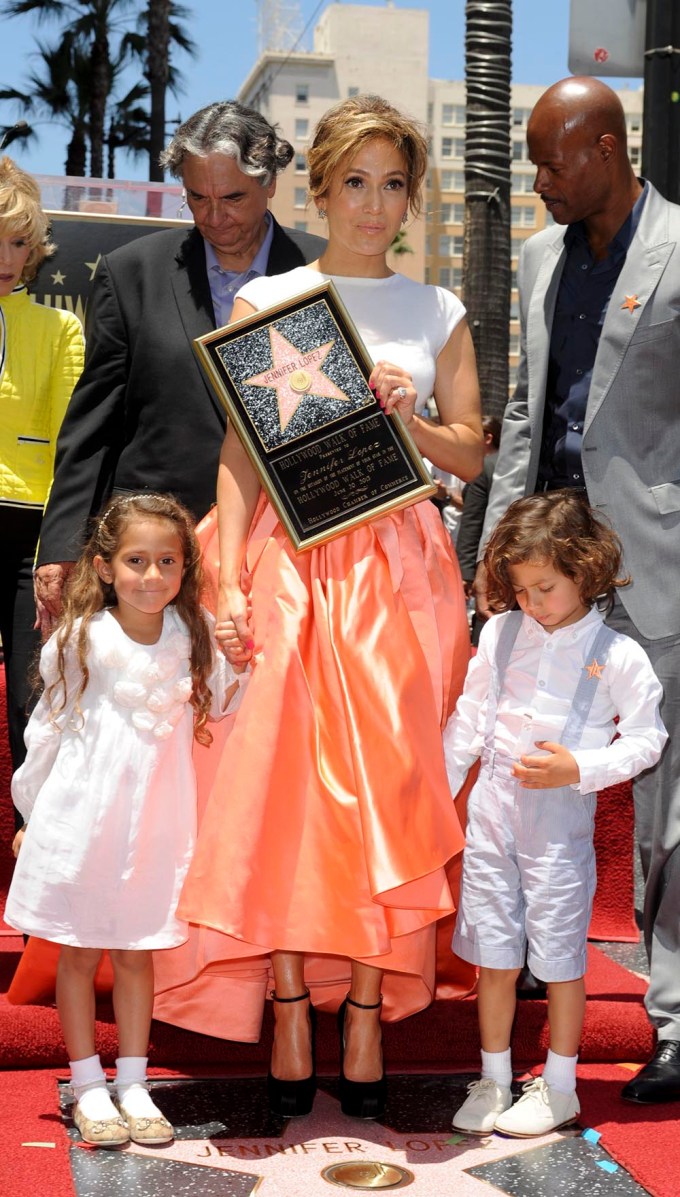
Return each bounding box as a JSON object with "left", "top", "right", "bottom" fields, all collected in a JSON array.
[{"left": 154, "top": 497, "right": 474, "bottom": 1041}]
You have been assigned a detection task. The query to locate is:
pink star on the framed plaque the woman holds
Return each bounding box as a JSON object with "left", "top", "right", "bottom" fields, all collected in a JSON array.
[{"left": 244, "top": 327, "right": 347, "bottom": 432}]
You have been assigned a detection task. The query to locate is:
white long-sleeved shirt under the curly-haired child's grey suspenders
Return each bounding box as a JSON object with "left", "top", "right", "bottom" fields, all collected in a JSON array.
[{"left": 444, "top": 608, "right": 668, "bottom": 794}]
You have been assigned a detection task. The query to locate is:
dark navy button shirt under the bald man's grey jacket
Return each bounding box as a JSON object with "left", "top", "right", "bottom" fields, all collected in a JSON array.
[{"left": 536, "top": 183, "right": 649, "bottom": 491}]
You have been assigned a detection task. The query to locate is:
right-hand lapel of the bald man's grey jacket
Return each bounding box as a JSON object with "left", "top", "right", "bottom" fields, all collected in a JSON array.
[{"left": 584, "top": 188, "right": 673, "bottom": 431}]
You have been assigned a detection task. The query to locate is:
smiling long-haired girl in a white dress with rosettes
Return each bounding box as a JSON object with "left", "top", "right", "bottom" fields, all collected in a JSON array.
[{"left": 6, "top": 494, "right": 245, "bottom": 1147}]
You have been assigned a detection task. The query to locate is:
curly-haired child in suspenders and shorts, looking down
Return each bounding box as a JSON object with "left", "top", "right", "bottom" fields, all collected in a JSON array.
[{"left": 444, "top": 491, "right": 667, "bottom": 1136}]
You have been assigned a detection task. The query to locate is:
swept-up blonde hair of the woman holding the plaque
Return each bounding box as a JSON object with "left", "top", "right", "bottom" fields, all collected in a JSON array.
[{"left": 306, "top": 96, "right": 427, "bottom": 217}]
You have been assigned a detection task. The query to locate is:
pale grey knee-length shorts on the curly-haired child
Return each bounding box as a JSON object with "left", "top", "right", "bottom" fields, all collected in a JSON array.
[{"left": 453, "top": 758, "right": 596, "bottom": 982}]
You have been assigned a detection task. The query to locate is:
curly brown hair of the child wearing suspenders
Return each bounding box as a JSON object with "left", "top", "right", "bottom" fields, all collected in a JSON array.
[{"left": 484, "top": 490, "right": 630, "bottom": 610}]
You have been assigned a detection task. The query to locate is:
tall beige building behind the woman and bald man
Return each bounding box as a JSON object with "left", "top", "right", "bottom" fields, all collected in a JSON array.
[{"left": 238, "top": 2, "right": 643, "bottom": 383}]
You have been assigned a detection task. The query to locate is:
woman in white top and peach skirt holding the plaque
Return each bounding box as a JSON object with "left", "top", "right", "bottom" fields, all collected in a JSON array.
[{"left": 156, "top": 97, "right": 482, "bottom": 1117}]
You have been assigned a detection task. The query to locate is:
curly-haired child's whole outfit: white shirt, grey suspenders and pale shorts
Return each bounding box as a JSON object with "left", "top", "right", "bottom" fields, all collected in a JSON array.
[{"left": 444, "top": 609, "right": 667, "bottom": 982}]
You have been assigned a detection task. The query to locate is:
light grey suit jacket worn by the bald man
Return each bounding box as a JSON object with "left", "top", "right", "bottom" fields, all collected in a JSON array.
[{"left": 482, "top": 186, "right": 680, "bottom": 640}]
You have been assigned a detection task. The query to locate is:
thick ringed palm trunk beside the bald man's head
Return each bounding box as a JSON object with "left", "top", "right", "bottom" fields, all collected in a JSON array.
[{"left": 463, "top": 0, "right": 512, "bottom": 415}]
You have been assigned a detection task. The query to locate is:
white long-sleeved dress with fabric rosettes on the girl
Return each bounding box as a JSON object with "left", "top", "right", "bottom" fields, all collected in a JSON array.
[{"left": 5, "top": 607, "right": 241, "bottom": 949}]
